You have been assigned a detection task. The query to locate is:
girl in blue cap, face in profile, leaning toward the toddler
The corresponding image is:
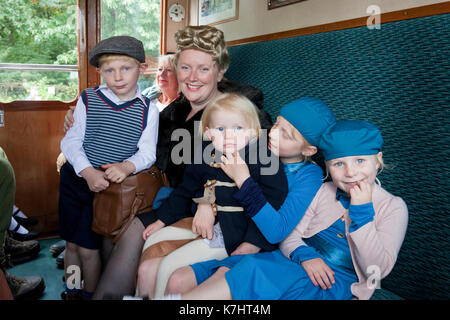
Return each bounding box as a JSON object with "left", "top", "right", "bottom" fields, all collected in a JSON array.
[{"left": 158, "top": 97, "right": 336, "bottom": 299}]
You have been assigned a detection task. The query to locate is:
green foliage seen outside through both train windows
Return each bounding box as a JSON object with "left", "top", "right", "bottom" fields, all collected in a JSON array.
[{"left": 0, "top": 0, "right": 160, "bottom": 102}]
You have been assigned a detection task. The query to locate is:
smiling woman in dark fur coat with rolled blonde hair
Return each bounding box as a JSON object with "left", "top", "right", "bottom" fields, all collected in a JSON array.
[{"left": 61, "top": 26, "right": 272, "bottom": 299}]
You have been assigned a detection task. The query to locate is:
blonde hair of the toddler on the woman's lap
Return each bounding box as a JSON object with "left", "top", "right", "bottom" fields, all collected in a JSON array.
[{"left": 200, "top": 93, "right": 261, "bottom": 138}]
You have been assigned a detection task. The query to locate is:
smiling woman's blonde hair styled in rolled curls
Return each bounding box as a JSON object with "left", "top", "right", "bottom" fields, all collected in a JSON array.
[{"left": 174, "top": 26, "right": 230, "bottom": 73}]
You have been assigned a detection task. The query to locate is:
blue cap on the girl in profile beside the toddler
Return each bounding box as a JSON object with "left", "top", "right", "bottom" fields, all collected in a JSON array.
[{"left": 280, "top": 97, "right": 336, "bottom": 146}]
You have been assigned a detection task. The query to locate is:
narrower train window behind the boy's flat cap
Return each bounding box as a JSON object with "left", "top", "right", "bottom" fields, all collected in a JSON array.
[{"left": 101, "top": 0, "right": 161, "bottom": 89}]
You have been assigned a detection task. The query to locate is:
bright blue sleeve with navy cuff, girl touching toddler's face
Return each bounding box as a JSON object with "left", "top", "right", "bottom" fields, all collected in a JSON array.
[{"left": 235, "top": 164, "right": 323, "bottom": 243}]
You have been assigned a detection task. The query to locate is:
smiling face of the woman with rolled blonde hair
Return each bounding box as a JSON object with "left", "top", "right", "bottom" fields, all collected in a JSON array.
[{"left": 177, "top": 49, "right": 223, "bottom": 107}]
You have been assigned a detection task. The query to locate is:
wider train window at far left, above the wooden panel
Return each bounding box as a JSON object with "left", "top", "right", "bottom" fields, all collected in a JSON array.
[{"left": 0, "top": 0, "right": 78, "bottom": 102}]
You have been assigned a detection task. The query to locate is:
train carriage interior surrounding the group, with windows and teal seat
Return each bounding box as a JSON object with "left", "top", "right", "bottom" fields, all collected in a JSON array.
[{"left": 0, "top": 0, "right": 450, "bottom": 300}]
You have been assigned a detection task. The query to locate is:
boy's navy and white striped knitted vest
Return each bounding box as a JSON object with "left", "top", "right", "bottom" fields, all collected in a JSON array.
[{"left": 81, "top": 87, "right": 150, "bottom": 168}]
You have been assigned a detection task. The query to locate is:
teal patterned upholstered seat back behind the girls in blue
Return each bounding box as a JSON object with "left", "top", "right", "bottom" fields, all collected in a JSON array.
[{"left": 226, "top": 14, "right": 450, "bottom": 299}]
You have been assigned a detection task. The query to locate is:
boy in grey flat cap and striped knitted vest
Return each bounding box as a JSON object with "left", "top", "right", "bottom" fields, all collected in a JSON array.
[{"left": 59, "top": 36, "right": 159, "bottom": 299}]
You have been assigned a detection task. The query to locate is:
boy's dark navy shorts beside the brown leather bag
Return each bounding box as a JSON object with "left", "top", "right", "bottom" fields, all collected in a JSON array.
[{"left": 58, "top": 162, "right": 102, "bottom": 249}]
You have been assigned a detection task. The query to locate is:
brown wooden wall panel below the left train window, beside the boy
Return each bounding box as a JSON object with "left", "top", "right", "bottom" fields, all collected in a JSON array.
[{"left": 0, "top": 108, "right": 67, "bottom": 232}]
